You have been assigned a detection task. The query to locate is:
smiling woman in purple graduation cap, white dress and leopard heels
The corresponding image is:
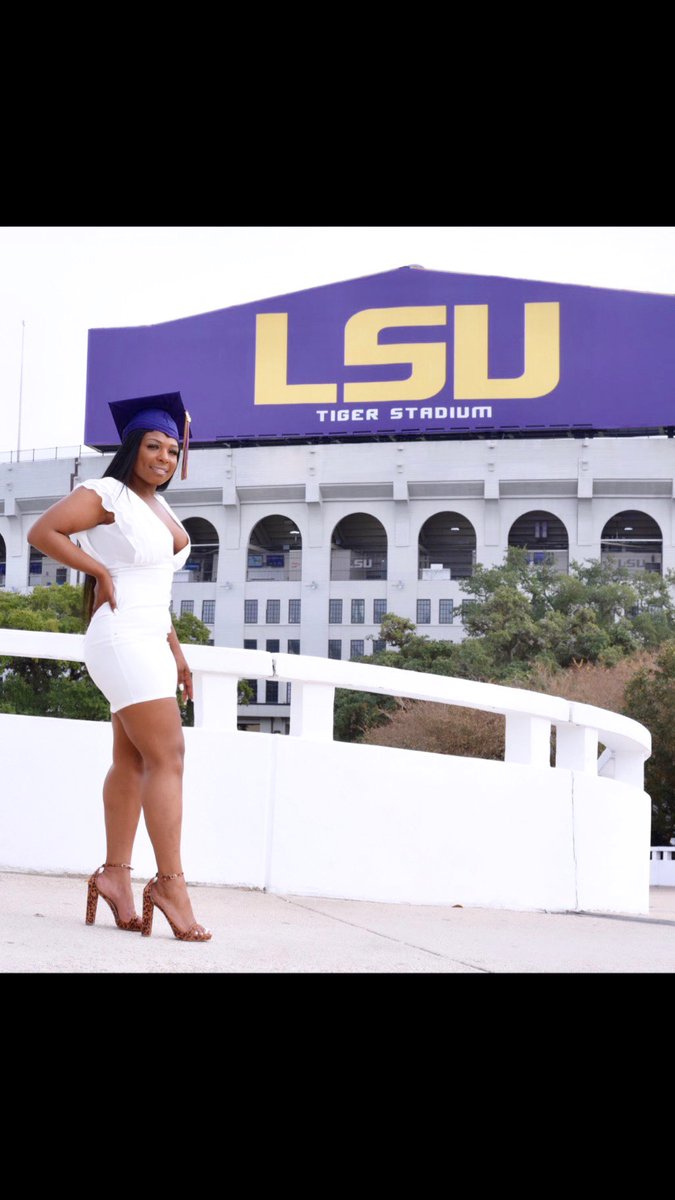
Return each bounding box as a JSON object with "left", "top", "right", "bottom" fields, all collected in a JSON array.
[{"left": 28, "top": 394, "right": 211, "bottom": 942}]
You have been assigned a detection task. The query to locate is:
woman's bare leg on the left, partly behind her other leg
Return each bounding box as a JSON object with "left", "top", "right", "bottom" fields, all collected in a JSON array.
[{"left": 96, "top": 713, "right": 143, "bottom": 920}]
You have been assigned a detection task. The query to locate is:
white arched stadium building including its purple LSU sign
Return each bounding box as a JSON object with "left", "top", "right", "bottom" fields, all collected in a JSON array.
[{"left": 0, "top": 266, "right": 675, "bottom": 733}]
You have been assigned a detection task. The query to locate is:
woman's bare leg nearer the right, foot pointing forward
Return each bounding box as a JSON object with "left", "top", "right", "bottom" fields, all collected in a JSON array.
[{"left": 117, "top": 698, "right": 207, "bottom": 929}]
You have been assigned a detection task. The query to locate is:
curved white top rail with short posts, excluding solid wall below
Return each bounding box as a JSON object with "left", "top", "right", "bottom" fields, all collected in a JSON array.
[{"left": 0, "top": 629, "right": 651, "bottom": 788}]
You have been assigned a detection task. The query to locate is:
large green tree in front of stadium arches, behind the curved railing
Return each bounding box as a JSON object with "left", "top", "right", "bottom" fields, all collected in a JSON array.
[{"left": 335, "top": 547, "right": 675, "bottom": 740}]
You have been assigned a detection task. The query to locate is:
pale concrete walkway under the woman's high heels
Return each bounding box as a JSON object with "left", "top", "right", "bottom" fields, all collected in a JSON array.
[{"left": 0, "top": 871, "right": 675, "bottom": 974}]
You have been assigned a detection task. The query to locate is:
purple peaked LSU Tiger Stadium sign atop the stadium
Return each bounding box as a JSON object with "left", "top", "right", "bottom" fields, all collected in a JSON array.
[{"left": 84, "top": 266, "right": 675, "bottom": 449}]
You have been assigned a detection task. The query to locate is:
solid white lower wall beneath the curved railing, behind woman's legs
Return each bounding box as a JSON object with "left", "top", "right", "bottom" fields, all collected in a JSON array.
[{"left": 0, "top": 714, "right": 650, "bottom": 913}]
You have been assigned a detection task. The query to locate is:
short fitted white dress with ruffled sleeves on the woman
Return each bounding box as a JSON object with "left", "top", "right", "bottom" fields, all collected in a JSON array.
[{"left": 73, "top": 476, "right": 190, "bottom": 713}]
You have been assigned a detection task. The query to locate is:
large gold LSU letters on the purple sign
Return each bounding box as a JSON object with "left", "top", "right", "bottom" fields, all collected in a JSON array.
[{"left": 255, "top": 302, "right": 560, "bottom": 404}]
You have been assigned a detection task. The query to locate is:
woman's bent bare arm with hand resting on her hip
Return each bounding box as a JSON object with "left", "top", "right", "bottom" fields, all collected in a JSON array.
[{"left": 26, "top": 487, "right": 115, "bottom": 608}]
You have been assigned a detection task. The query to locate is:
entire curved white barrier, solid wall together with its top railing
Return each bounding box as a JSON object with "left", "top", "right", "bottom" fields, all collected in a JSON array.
[{"left": 0, "top": 629, "right": 651, "bottom": 912}]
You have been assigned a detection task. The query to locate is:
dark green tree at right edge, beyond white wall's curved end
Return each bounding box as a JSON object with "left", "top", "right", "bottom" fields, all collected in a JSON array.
[{"left": 625, "top": 640, "right": 675, "bottom": 846}]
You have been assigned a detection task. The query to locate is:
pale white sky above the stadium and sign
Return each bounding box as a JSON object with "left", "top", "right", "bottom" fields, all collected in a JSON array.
[{"left": 0, "top": 226, "right": 675, "bottom": 451}]
